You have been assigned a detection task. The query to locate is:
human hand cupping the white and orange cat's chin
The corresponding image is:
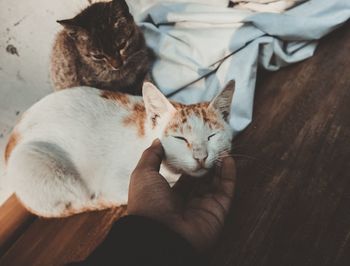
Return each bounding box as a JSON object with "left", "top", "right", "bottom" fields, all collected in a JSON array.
[{"left": 128, "top": 140, "right": 236, "bottom": 251}]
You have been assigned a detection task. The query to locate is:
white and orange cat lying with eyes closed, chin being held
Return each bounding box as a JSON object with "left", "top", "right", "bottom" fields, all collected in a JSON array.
[{"left": 5, "top": 81, "right": 234, "bottom": 217}]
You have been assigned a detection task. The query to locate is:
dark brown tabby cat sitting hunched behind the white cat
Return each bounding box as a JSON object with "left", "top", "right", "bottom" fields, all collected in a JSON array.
[{"left": 51, "top": 0, "right": 154, "bottom": 94}]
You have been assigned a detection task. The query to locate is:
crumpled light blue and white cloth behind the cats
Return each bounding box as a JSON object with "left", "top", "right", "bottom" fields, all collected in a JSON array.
[{"left": 129, "top": 0, "right": 350, "bottom": 133}]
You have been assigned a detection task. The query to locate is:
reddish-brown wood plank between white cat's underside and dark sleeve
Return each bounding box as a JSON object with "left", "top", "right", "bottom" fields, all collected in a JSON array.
[{"left": 0, "top": 206, "right": 126, "bottom": 266}]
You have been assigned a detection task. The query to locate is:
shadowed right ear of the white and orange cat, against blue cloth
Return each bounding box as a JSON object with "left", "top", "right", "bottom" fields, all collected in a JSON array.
[{"left": 209, "top": 80, "right": 235, "bottom": 121}]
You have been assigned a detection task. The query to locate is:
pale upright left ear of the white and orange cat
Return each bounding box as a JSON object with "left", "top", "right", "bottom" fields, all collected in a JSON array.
[{"left": 142, "top": 82, "right": 176, "bottom": 126}]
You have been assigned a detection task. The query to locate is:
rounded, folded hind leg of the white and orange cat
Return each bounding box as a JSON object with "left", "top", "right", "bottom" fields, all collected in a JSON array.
[{"left": 6, "top": 141, "right": 92, "bottom": 217}]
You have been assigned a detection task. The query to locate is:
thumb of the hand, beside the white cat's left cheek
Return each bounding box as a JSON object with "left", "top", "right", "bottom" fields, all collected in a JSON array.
[{"left": 135, "top": 139, "right": 164, "bottom": 172}]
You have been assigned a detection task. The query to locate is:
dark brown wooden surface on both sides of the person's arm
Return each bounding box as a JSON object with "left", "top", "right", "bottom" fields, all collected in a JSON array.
[{"left": 0, "top": 23, "right": 350, "bottom": 266}]
